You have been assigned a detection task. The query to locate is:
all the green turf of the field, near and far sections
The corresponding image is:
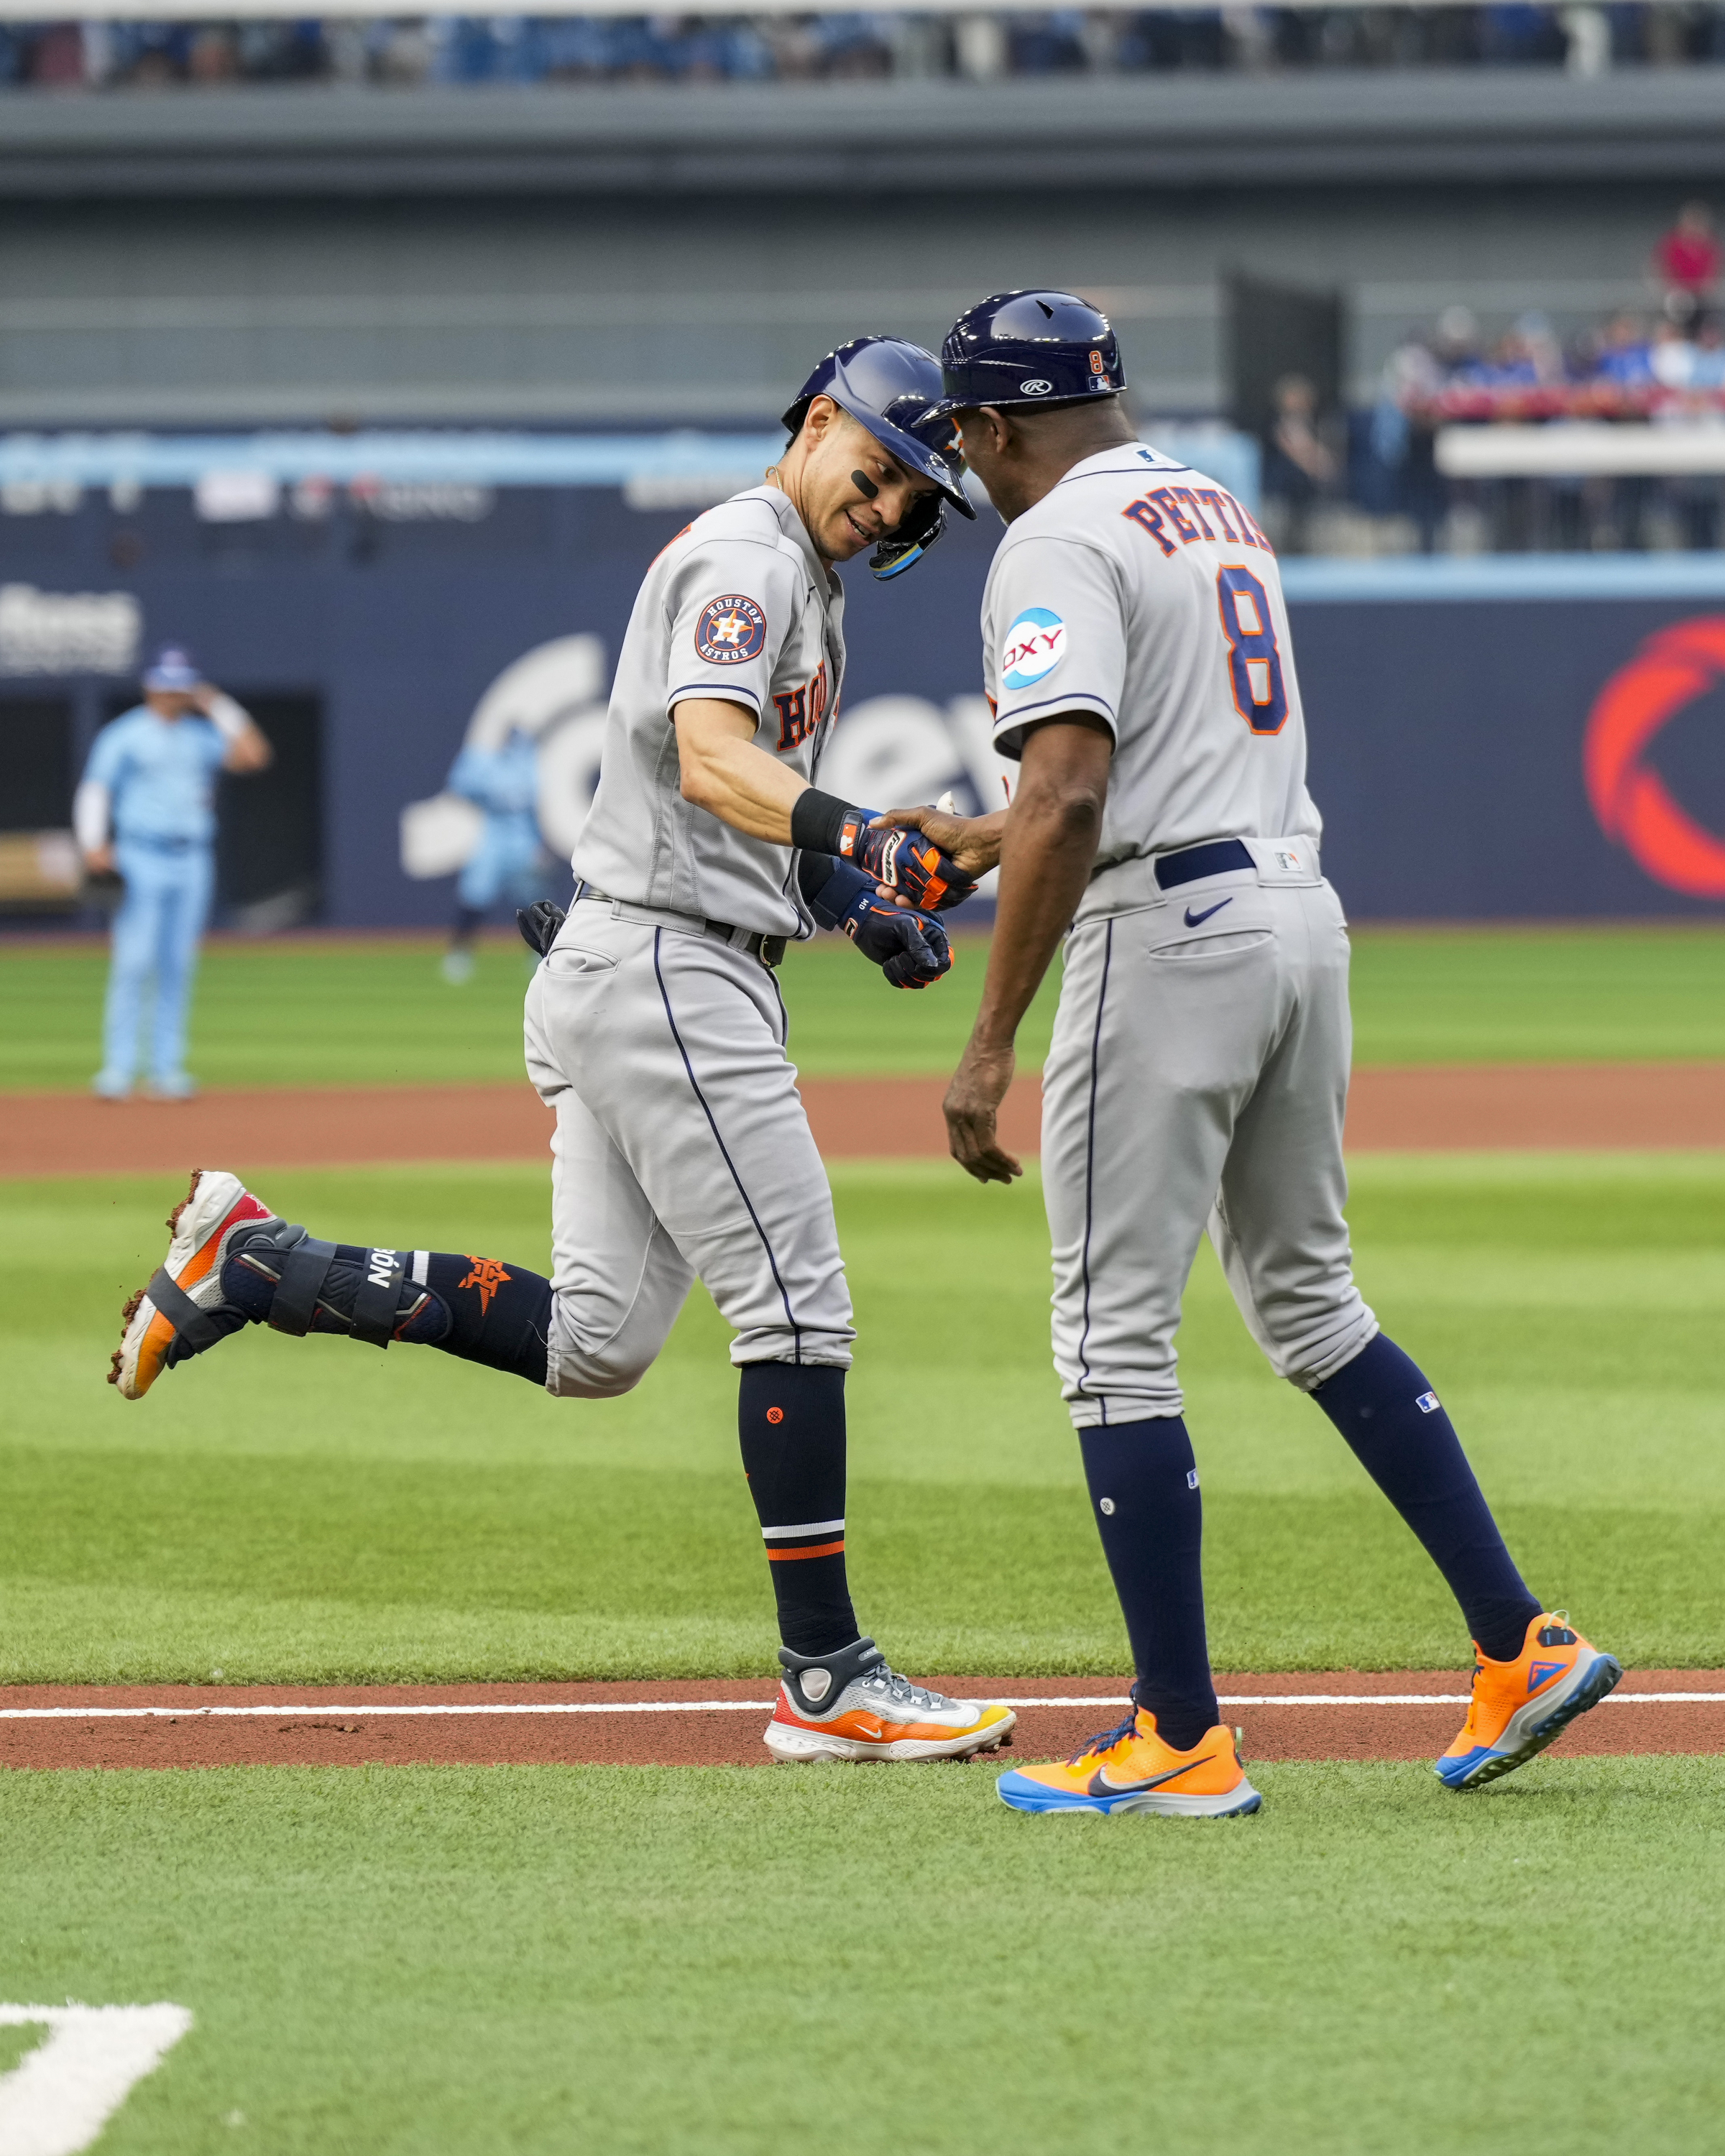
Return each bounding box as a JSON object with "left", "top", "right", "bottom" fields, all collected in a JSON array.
[{"left": 0, "top": 931, "right": 1725, "bottom": 2156}]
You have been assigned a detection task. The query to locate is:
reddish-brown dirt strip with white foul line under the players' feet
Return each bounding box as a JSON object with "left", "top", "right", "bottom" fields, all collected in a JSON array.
[{"left": 0, "top": 1669, "right": 1725, "bottom": 1768}]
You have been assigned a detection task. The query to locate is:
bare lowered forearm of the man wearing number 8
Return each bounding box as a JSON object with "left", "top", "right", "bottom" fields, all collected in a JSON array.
[{"left": 970, "top": 785, "right": 1102, "bottom": 1052}]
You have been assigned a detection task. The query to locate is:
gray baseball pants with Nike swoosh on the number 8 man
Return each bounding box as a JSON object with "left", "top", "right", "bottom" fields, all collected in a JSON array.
[{"left": 1041, "top": 841, "right": 1378, "bottom": 1429}]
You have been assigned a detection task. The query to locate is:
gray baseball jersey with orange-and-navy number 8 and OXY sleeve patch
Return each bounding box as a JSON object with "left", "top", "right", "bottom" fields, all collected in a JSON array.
[{"left": 983, "top": 444, "right": 1320, "bottom": 867}]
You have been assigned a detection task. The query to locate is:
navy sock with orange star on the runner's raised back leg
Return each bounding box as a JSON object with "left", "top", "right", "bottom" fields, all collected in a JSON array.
[{"left": 214, "top": 1240, "right": 552, "bottom": 1384}]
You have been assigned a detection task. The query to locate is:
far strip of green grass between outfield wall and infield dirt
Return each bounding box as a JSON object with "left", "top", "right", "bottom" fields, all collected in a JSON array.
[{"left": 0, "top": 927, "right": 1725, "bottom": 1089}]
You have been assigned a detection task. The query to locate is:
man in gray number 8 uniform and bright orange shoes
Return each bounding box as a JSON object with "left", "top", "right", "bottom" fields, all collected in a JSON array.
[{"left": 884, "top": 291, "right": 1622, "bottom": 1815}]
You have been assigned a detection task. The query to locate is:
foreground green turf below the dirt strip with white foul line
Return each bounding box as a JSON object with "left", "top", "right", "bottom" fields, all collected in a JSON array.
[{"left": 0, "top": 1755, "right": 1725, "bottom": 2156}]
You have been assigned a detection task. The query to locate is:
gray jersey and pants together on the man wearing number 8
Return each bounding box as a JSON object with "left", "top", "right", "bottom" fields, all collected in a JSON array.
[{"left": 983, "top": 444, "right": 1378, "bottom": 1427}]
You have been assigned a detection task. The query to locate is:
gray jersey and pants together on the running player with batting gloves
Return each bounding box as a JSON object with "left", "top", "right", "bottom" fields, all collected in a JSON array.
[{"left": 526, "top": 487, "right": 854, "bottom": 1399}]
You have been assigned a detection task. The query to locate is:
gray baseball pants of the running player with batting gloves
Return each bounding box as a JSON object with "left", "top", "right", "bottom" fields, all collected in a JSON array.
[{"left": 526, "top": 899, "right": 856, "bottom": 1399}]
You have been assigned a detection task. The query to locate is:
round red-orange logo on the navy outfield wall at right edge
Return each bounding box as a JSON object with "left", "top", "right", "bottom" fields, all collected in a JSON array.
[{"left": 1581, "top": 614, "right": 1725, "bottom": 899}]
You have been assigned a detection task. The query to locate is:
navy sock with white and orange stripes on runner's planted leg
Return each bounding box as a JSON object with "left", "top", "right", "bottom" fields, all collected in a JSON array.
[{"left": 737, "top": 1363, "right": 858, "bottom": 1654}]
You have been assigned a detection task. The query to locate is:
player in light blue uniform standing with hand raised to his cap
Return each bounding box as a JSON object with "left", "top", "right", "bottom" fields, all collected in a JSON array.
[{"left": 71, "top": 645, "right": 272, "bottom": 1100}]
